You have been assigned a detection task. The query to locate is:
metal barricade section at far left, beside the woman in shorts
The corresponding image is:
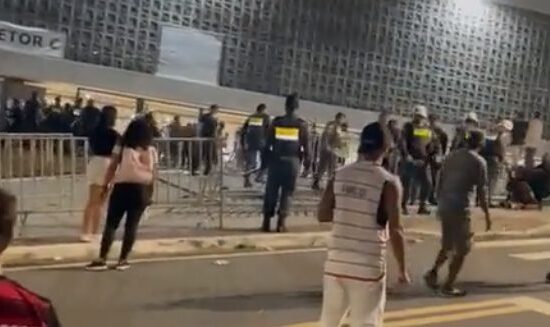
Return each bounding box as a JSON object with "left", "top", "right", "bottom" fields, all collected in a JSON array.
[{"left": 0, "top": 134, "right": 88, "bottom": 233}]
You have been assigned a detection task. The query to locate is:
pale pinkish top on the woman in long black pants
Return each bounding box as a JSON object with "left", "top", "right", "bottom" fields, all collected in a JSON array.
[{"left": 113, "top": 145, "right": 158, "bottom": 185}]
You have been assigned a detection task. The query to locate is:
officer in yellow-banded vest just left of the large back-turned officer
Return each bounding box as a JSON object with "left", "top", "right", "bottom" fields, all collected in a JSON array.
[{"left": 241, "top": 103, "right": 271, "bottom": 188}]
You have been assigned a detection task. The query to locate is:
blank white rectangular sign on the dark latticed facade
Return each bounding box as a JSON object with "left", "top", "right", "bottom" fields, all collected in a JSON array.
[{"left": 157, "top": 26, "right": 222, "bottom": 85}]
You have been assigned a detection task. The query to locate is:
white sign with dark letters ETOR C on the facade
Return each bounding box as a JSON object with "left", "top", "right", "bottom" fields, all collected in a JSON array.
[{"left": 0, "top": 21, "right": 66, "bottom": 58}]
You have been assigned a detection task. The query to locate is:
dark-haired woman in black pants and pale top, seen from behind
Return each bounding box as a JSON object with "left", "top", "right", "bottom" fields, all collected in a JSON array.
[{"left": 86, "top": 119, "right": 158, "bottom": 271}]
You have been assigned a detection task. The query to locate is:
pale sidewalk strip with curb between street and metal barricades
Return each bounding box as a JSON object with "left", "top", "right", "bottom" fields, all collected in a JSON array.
[{"left": 2, "top": 209, "right": 550, "bottom": 266}]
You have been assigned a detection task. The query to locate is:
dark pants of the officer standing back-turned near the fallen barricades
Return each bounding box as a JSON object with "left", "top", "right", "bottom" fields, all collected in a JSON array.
[{"left": 263, "top": 157, "right": 300, "bottom": 219}]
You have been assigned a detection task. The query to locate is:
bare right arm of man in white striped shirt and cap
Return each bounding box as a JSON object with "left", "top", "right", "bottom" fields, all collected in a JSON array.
[{"left": 383, "top": 179, "right": 409, "bottom": 282}]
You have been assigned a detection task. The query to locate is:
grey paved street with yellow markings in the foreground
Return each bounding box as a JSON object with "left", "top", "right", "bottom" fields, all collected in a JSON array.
[{"left": 8, "top": 240, "right": 550, "bottom": 327}]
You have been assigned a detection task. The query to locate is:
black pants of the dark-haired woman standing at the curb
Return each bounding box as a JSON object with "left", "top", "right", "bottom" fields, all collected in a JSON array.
[{"left": 99, "top": 183, "right": 150, "bottom": 260}]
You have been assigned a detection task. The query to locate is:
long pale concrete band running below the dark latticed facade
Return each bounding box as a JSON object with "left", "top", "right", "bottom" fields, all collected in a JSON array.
[{"left": 0, "top": 50, "right": 450, "bottom": 130}]
